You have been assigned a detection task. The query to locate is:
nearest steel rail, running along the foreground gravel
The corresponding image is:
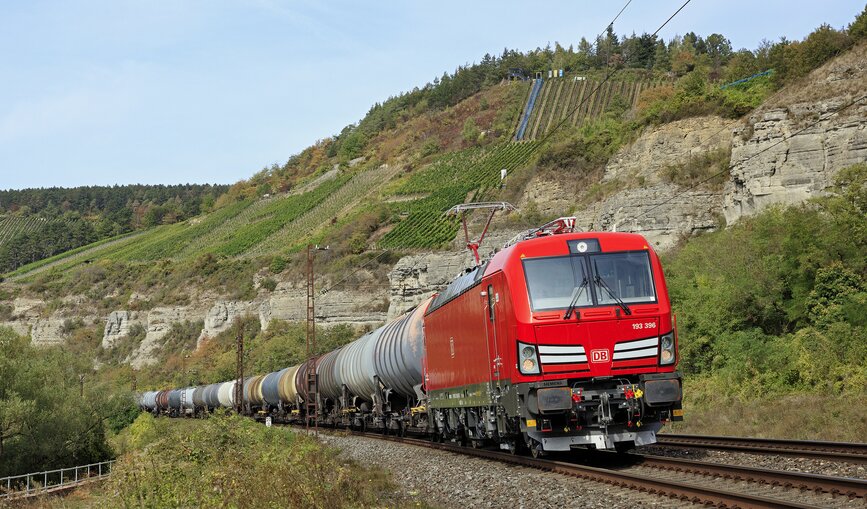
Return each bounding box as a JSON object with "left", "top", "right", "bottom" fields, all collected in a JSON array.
[{"left": 328, "top": 430, "right": 842, "bottom": 509}]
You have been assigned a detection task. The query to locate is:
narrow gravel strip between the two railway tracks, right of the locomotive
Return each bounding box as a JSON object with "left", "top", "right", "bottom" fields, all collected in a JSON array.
[{"left": 636, "top": 445, "right": 867, "bottom": 480}]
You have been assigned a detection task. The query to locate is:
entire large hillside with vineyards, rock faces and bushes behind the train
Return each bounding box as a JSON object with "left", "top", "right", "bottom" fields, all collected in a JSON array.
[{"left": 0, "top": 10, "right": 867, "bottom": 476}]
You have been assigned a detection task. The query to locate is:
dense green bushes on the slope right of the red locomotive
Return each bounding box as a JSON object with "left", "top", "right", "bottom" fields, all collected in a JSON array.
[{"left": 664, "top": 165, "right": 867, "bottom": 398}]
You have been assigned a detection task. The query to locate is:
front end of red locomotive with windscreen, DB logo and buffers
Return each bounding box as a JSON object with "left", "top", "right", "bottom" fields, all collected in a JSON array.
[{"left": 504, "top": 232, "right": 683, "bottom": 451}]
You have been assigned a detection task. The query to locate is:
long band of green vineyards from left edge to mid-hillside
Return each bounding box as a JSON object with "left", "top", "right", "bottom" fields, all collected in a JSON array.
[{"left": 3, "top": 142, "right": 535, "bottom": 280}]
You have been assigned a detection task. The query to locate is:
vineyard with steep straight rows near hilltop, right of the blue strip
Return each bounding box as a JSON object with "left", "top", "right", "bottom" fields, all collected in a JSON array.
[{"left": 516, "top": 77, "right": 663, "bottom": 140}]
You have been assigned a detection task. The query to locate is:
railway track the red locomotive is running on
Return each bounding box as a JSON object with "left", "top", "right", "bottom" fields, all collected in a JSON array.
[{"left": 328, "top": 432, "right": 867, "bottom": 508}]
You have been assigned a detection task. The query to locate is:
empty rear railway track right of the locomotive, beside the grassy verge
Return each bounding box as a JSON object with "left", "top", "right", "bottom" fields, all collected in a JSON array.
[{"left": 657, "top": 433, "right": 867, "bottom": 464}]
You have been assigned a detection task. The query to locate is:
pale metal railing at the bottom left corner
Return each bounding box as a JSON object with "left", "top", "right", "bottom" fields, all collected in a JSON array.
[{"left": 0, "top": 460, "right": 116, "bottom": 500}]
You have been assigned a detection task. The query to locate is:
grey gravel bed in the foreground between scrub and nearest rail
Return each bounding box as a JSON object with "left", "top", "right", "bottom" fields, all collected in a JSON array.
[{"left": 320, "top": 433, "right": 694, "bottom": 509}]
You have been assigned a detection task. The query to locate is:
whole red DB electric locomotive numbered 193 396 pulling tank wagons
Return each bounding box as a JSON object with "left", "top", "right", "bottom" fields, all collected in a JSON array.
[{"left": 424, "top": 218, "right": 683, "bottom": 455}]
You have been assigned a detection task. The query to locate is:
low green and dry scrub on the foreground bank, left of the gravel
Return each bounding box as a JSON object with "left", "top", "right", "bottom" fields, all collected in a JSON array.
[{"left": 107, "top": 416, "right": 394, "bottom": 508}]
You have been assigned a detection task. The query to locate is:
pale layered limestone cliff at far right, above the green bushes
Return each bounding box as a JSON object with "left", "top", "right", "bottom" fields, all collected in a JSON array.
[{"left": 724, "top": 97, "right": 867, "bottom": 223}]
